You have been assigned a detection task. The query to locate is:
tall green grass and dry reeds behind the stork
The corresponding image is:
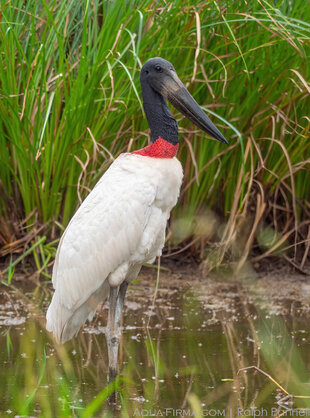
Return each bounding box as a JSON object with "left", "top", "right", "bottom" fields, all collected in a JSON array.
[{"left": 0, "top": 0, "right": 310, "bottom": 268}]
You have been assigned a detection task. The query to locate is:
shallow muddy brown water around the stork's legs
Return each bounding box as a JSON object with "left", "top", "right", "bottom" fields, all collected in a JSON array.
[{"left": 0, "top": 271, "right": 310, "bottom": 417}]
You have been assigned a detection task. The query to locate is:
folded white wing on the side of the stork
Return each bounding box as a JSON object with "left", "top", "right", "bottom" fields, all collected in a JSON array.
[{"left": 46, "top": 157, "right": 156, "bottom": 342}]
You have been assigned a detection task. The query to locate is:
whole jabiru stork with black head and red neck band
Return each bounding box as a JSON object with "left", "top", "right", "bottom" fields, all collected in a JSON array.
[{"left": 46, "top": 58, "right": 227, "bottom": 380}]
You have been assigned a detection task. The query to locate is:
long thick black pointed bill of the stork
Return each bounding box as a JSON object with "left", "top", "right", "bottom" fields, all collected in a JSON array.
[{"left": 161, "top": 72, "right": 228, "bottom": 144}]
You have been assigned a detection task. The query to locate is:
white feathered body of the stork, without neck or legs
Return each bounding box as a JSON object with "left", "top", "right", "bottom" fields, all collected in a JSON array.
[{"left": 46, "top": 153, "right": 183, "bottom": 343}]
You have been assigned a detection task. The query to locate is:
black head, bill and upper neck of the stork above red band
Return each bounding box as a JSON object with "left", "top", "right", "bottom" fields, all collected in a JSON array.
[{"left": 140, "top": 57, "right": 228, "bottom": 145}]
